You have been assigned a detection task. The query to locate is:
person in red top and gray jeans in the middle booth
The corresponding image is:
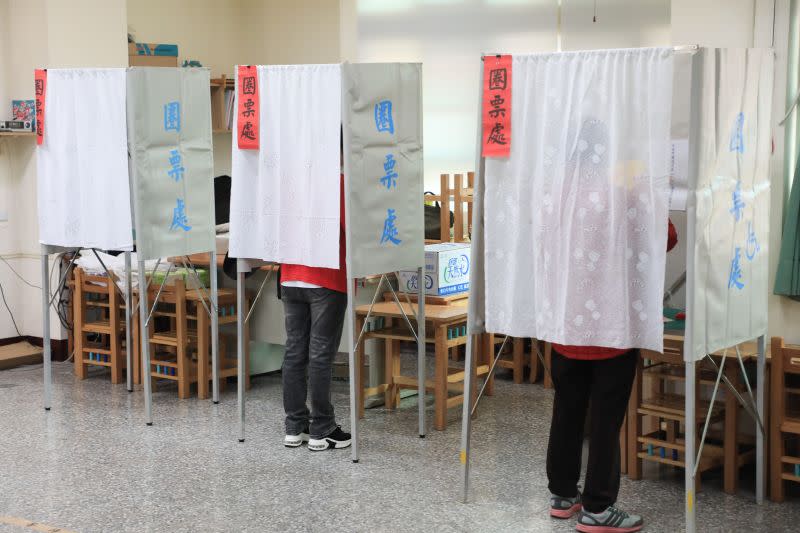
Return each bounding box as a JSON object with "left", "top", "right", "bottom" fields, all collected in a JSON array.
[{"left": 278, "top": 137, "right": 350, "bottom": 451}]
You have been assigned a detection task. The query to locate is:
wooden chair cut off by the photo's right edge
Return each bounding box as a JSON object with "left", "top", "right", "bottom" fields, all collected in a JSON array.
[{"left": 769, "top": 337, "right": 800, "bottom": 502}]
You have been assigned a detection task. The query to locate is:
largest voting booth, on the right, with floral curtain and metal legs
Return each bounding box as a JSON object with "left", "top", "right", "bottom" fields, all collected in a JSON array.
[{"left": 460, "top": 46, "right": 774, "bottom": 531}]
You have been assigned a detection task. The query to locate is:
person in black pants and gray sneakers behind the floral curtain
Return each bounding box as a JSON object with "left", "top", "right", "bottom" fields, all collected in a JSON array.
[{"left": 547, "top": 221, "right": 678, "bottom": 533}]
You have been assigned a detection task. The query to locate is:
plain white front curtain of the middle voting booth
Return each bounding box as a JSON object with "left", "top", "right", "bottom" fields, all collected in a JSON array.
[{"left": 230, "top": 65, "right": 344, "bottom": 268}]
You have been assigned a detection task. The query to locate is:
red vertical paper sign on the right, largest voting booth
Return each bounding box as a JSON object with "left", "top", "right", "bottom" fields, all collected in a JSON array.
[{"left": 481, "top": 55, "right": 511, "bottom": 157}]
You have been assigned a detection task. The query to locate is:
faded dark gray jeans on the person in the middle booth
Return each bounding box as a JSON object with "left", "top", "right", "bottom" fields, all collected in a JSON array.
[{"left": 281, "top": 287, "right": 347, "bottom": 439}]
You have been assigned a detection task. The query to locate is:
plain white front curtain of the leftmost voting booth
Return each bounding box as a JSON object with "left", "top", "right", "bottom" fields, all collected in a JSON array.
[{"left": 36, "top": 68, "right": 133, "bottom": 250}]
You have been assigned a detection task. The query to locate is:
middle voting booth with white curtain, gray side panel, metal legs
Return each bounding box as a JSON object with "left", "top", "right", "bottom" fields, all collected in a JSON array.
[{"left": 229, "top": 63, "right": 425, "bottom": 454}]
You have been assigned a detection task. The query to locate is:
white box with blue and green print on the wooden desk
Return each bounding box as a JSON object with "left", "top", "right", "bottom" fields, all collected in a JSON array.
[{"left": 400, "top": 242, "right": 470, "bottom": 296}]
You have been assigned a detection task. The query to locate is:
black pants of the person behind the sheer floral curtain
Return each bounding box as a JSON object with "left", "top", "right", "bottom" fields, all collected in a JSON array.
[{"left": 547, "top": 350, "right": 639, "bottom": 513}]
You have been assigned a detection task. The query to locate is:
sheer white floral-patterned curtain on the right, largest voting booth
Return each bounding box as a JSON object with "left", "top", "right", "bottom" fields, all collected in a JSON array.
[{"left": 484, "top": 48, "right": 673, "bottom": 351}]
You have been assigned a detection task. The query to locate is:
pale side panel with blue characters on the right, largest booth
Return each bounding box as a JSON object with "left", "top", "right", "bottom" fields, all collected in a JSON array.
[{"left": 685, "top": 48, "right": 774, "bottom": 360}]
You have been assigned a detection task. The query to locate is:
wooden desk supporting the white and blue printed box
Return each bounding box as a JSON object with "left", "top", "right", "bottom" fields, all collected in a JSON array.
[{"left": 355, "top": 300, "right": 493, "bottom": 430}]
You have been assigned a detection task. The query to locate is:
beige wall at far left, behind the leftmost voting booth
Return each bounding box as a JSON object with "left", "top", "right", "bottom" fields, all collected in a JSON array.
[{"left": 0, "top": 0, "right": 127, "bottom": 338}]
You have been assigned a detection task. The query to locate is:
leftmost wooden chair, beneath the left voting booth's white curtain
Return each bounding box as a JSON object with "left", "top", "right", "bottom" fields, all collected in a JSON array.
[{"left": 72, "top": 267, "right": 126, "bottom": 384}]
